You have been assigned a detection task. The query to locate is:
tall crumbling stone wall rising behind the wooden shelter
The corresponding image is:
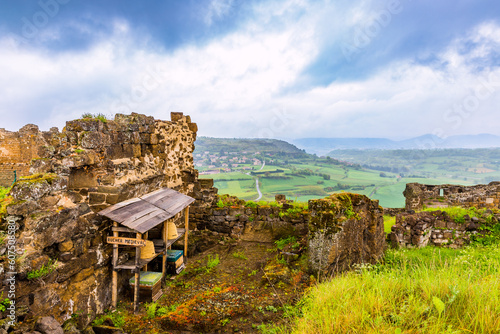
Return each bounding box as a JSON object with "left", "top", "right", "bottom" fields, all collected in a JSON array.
[{"left": 0, "top": 113, "right": 216, "bottom": 325}]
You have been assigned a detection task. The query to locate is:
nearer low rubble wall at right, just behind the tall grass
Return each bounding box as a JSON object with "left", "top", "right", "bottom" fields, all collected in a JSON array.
[{"left": 389, "top": 210, "right": 500, "bottom": 248}]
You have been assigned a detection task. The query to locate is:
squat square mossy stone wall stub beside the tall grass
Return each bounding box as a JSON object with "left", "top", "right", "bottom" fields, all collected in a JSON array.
[{"left": 308, "top": 193, "right": 385, "bottom": 274}]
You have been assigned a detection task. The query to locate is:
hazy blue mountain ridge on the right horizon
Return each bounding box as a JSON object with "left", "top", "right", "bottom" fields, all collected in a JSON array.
[{"left": 290, "top": 133, "right": 500, "bottom": 155}]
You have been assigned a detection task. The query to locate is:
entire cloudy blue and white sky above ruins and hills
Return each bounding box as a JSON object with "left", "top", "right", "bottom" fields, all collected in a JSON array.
[{"left": 0, "top": 0, "right": 500, "bottom": 139}]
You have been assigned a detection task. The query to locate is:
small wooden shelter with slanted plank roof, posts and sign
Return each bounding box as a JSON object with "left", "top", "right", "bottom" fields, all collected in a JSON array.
[{"left": 99, "top": 188, "right": 194, "bottom": 312}]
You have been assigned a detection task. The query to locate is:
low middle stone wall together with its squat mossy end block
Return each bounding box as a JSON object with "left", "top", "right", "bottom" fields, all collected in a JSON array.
[{"left": 189, "top": 193, "right": 386, "bottom": 275}]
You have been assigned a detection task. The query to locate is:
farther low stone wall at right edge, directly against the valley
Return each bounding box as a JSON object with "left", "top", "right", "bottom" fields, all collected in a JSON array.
[{"left": 403, "top": 182, "right": 500, "bottom": 210}]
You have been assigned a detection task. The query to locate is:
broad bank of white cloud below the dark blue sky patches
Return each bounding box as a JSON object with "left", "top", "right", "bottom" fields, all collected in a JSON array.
[{"left": 0, "top": 0, "right": 500, "bottom": 138}]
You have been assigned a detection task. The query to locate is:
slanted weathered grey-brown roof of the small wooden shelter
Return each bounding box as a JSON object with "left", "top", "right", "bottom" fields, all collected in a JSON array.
[{"left": 99, "top": 188, "right": 194, "bottom": 233}]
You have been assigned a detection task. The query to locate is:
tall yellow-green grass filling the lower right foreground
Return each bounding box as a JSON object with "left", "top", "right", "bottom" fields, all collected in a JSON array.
[{"left": 266, "top": 245, "right": 500, "bottom": 334}]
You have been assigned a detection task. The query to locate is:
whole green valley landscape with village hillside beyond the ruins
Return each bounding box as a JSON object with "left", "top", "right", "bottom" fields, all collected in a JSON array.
[{"left": 195, "top": 138, "right": 500, "bottom": 208}]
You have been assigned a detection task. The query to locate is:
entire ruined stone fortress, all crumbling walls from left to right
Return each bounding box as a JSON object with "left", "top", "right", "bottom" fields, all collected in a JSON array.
[{"left": 0, "top": 113, "right": 500, "bottom": 327}]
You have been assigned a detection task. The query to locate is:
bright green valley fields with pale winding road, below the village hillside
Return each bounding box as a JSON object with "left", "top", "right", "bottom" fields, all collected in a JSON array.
[{"left": 200, "top": 161, "right": 472, "bottom": 207}]
